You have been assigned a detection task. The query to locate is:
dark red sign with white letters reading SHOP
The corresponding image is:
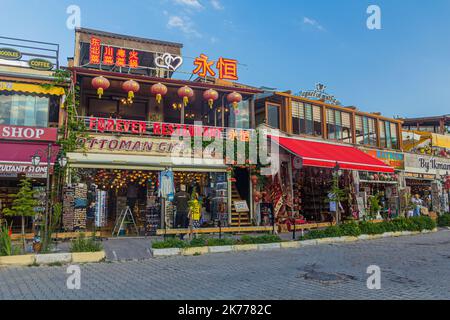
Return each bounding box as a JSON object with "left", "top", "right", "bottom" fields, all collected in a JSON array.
[{"left": 0, "top": 125, "right": 58, "bottom": 141}]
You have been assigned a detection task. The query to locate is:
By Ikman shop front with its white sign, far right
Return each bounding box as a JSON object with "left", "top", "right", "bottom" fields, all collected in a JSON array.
[{"left": 405, "top": 153, "right": 450, "bottom": 214}]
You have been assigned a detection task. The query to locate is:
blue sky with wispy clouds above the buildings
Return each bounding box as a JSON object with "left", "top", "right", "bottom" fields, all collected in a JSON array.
[{"left": 0, "top": 0, "right": 450, "bottom": 116}]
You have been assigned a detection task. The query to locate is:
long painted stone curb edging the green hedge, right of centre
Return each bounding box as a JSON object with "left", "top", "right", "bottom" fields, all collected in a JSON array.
[{"left": 150, "top": 229, "right": 437, "bottom": 258}]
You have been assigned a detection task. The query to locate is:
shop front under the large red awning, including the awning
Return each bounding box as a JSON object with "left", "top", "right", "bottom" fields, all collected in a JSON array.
[{"left": 255, "top": 137, "right": 394, "bottom": 231}]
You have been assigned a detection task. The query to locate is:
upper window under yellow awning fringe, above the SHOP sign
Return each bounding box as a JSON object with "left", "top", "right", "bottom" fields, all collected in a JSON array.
[{"left": 0, "top": 94, "right": 50, "bottom": 127}]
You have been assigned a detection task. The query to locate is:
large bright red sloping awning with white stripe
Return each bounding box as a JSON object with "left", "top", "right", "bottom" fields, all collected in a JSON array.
[{"left": 272, "top": 137, "right": 394, "bottom": 173}]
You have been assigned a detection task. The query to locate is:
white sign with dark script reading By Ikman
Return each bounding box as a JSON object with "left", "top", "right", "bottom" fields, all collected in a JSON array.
[{"left": 405, "top": 153, "right": 450, "bottom": 175}]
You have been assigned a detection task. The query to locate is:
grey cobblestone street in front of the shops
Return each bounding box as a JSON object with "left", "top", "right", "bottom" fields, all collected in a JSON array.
[{"left": 0, "top": 230, "right": 450, "bottom": 300}]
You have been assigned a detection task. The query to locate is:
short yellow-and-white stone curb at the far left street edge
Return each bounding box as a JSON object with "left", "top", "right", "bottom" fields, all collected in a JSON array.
[{"left": 0, "top": 251, "right": 106, "bottom": 266}]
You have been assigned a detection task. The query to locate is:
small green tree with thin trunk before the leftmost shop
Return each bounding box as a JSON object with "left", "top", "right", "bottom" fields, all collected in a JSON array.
[{"left": 3, "top": 179, "right": 38, "bottom": 251}]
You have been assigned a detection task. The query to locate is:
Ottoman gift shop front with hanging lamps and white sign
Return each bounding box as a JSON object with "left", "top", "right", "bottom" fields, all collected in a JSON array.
[{"left": 63, "top": 121, "right": 260, "bottom": 235}]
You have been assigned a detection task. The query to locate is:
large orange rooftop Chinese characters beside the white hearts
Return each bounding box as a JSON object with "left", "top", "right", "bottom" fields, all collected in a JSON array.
[{"left": 192, "top": 54, "right": 239, "bottom": 81}]
